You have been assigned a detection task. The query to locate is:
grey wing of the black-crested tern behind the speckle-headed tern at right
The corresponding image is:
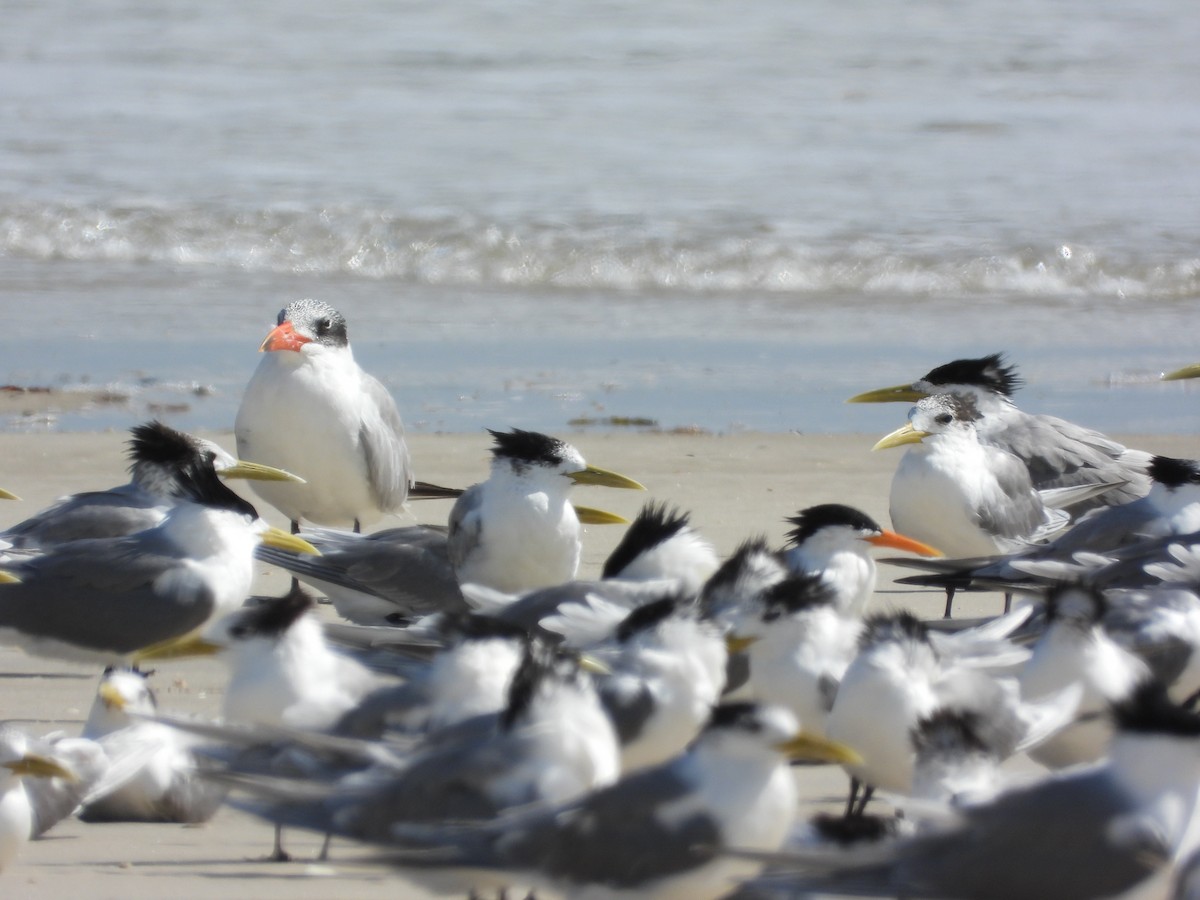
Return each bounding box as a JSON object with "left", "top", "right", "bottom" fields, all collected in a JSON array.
[{"left": 991, "top": 414, "right": 1150, "bottom": 506}]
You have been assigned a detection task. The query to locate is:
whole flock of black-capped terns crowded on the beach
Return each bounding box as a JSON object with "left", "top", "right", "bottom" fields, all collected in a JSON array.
[{"left": 0, "top": 300, "right": 1200, "bottom": 900}]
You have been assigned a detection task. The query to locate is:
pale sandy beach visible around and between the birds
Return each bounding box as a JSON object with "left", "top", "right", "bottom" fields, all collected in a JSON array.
[{"left": 0, "top": 432, "right": 1196, "bottom": 900}]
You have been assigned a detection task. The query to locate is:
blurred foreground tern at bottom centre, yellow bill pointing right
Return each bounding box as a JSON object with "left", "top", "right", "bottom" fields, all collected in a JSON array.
[{"left": 225, "top": 703, "right": 853, "bottom": 900}]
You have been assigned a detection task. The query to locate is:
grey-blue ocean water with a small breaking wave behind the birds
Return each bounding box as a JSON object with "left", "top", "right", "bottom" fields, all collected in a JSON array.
[{"left": 0, "top": 0, "right": 1200, "bottom": 433}]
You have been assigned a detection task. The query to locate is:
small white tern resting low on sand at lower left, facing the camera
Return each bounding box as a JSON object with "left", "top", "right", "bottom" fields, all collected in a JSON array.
[{"left": 79, "top": 668, "right": 224, "bottom": 823}]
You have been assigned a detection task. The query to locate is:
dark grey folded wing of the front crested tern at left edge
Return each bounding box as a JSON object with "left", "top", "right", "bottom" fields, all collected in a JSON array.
[{"left": 0, "top": 536, "right": 215, "bottom": 655}]
